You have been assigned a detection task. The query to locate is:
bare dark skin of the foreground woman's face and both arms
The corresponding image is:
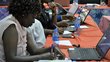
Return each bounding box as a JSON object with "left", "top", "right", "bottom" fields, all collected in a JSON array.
[{"left": 2, "top": 14, "right": 53, "bottom": 62}]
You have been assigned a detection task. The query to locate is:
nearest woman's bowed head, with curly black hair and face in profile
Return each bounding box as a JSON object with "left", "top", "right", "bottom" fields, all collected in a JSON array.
[{"left": 8, "top": 0, "right": 39, "bottom": 27}]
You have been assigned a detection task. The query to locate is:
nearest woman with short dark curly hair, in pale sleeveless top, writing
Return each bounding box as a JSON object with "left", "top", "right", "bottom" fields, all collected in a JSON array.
[{"left": 0, "top": 0, "right": 63, "bottom": 62}]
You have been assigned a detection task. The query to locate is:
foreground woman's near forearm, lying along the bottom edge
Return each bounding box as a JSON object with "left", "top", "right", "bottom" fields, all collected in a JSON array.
[{"left": 6, "top": 53, "right": 53, "bottom": 62}]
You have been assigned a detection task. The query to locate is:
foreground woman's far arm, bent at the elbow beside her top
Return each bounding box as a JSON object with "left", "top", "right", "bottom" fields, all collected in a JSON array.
[{"left": 27, "top": 28, "right": 50, "bottom": 55}]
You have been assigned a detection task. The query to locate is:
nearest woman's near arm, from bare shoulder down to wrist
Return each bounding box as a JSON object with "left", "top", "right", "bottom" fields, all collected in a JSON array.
[{"left": 2, "top": 25, "right": 52, "bottom": 62}]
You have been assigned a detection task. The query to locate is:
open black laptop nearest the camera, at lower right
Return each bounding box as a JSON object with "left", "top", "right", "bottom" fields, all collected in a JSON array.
[{"left": 68, "top": 25, "right": 110, "bottom": 61}]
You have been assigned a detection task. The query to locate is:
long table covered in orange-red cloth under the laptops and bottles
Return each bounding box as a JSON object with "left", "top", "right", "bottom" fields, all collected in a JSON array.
[{"left": 45, "top": 16, "right": 109, "bottom": 61}]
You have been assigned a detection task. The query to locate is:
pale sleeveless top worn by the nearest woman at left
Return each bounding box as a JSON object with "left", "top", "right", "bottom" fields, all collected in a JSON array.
[{"left": 0, "top": 15, "right": 27, "bottom": 62}]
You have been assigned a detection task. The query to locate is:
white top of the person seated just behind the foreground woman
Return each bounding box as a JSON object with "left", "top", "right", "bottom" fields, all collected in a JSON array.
[{"left": 28, "top": 19, "right": 46, "bottom": 48}]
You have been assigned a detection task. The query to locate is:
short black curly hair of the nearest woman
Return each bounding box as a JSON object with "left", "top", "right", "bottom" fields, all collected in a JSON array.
[{"left": 8, "top": 0, "right": 40, "bottom": 16}]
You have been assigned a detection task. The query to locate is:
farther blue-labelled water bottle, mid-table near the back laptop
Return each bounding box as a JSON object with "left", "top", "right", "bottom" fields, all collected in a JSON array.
[{"left": 74, "top": 17, "right": 81, "bottom": 37}]
